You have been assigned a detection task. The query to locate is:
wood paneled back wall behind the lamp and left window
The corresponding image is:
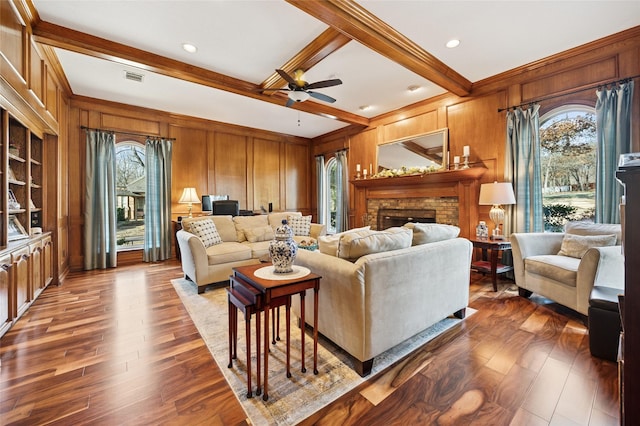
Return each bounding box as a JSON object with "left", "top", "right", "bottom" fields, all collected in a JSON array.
[{"left": 69, "top": 97, "right": 312, "bottom": 270}]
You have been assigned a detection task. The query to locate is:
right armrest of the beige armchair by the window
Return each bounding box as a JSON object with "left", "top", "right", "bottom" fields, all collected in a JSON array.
[{"left": 576, "top": 246, "right": 624, "bottom": 312}]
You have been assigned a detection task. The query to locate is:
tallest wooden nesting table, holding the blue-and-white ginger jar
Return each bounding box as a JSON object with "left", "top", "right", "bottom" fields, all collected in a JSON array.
[{"left": 233, "top": 263, "right": 322, "bottom": 401}]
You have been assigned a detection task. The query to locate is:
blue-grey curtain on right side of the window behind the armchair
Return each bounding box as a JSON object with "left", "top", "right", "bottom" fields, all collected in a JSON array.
[{"left": 596, "top": 81, "right": 633, "bottom": 223}]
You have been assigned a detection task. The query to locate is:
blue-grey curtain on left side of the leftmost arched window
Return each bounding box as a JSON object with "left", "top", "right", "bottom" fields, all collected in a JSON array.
[{"left": 83, "top": 130, "right": 118, "bottom": 270}]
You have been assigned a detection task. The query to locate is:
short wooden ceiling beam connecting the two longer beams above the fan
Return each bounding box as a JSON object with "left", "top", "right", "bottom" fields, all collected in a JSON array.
[{"left": 261, "top": 27, "right": 351, "bottom": 89}]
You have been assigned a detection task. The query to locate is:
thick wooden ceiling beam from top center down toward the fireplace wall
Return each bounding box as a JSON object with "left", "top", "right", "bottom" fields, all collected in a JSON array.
[{"left": 285, "top": 0, "right": 472, "bottom": 96}]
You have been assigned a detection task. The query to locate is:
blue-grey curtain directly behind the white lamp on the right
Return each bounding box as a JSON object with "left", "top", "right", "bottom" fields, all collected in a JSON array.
[{"left": 505, "top": 105, "right": 544, "bottom": 235}]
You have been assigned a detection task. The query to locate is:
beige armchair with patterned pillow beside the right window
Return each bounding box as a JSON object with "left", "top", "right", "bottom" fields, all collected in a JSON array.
[{"left": 511, "top": 222, "right": 624, "bottom": 315}]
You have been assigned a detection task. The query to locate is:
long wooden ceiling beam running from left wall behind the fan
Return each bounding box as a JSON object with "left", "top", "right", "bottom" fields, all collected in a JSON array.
[{"left": 32, "top": 21, "right": 369, "bottom": 126}]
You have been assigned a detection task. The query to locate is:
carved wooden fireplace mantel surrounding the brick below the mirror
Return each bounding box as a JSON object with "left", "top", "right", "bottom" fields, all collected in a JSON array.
[{"left": 350, "top": 167, "right": 487, "bottom": 238}]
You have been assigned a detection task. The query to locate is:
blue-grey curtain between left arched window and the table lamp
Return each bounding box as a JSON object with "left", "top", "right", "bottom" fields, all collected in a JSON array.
[{"left": 143, "top": 139, "right": 172, "bottom": 262}]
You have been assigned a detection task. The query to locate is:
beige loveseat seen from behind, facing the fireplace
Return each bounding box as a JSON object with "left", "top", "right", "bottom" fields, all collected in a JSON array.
[{"left": 292, "top": 224, "right": 472, "bottom": 376}]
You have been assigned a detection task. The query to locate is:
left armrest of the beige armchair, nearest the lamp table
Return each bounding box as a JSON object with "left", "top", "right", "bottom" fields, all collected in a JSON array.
[{"left": 510, "top": 232, "right": 564, "bottom": 288}]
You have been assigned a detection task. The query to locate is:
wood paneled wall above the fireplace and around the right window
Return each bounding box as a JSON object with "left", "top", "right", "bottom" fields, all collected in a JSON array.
[{"left": 313, "top": 27, "right": 640, "bottom": 233}]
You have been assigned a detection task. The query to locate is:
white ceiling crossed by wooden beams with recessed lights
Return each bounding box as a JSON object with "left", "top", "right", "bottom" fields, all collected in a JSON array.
[{"left": 32, "top": 0, "right": 640, "bottom": 138}]
